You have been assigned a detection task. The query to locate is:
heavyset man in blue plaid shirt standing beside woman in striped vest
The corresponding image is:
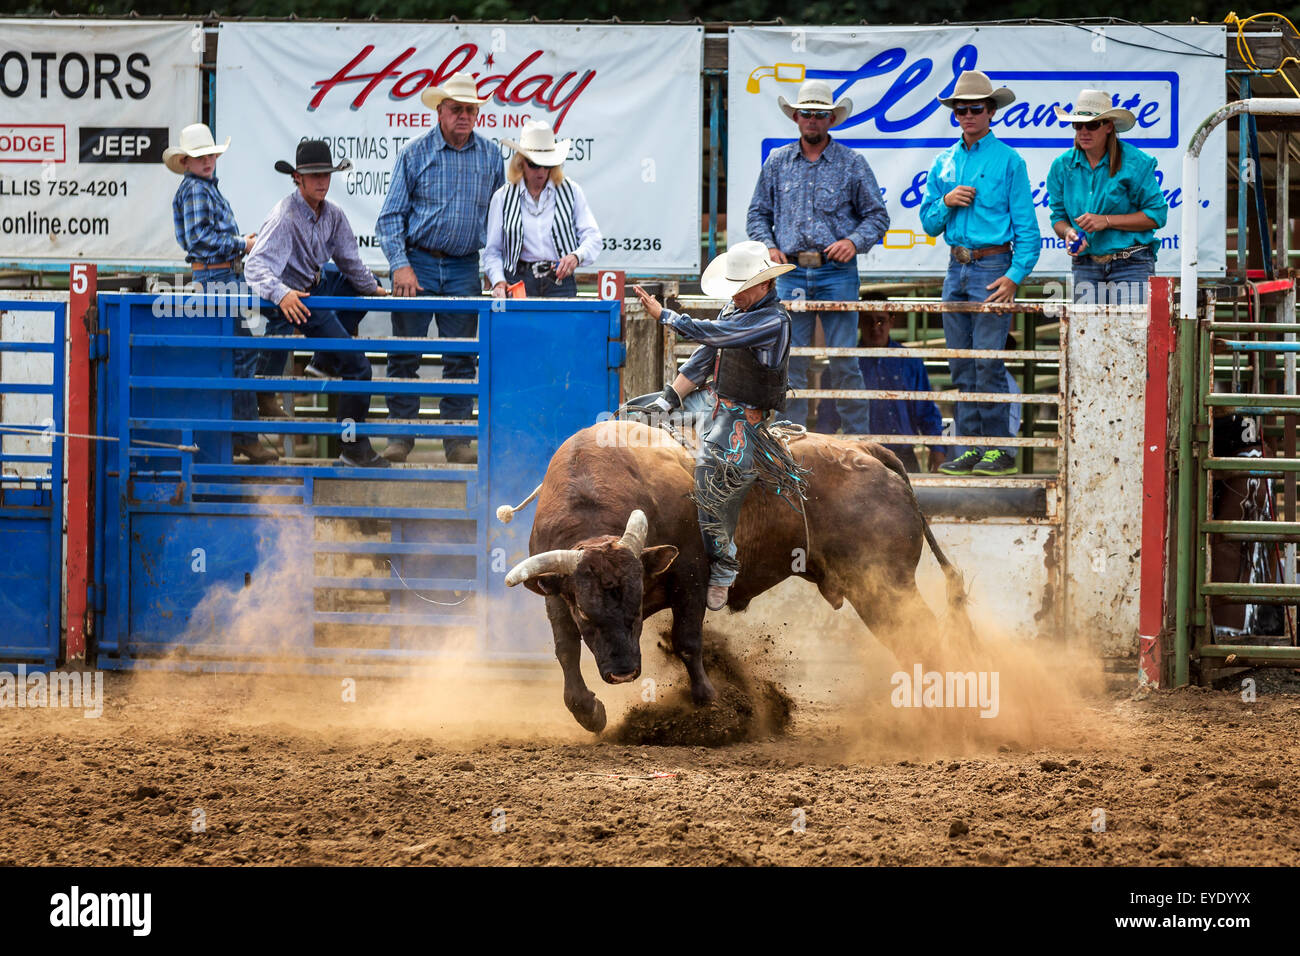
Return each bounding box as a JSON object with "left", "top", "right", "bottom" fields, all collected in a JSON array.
[{"left": 374, "top": 73, "right": 506, "bottom": 464}]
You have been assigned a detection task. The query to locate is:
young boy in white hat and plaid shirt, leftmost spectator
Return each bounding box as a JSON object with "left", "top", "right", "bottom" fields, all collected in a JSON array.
[{"left": 163, "top": 122, "right": 280, "bottom": 464}]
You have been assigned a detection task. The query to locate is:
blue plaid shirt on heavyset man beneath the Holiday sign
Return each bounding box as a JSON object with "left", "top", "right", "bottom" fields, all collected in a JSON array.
[{"left": 374, "top": 126, "right": 506, "bottom": 269}]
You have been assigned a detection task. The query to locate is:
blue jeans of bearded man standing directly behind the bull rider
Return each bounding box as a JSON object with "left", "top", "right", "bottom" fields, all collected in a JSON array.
[{"left": 776, "top": 259, "right": 871, "bottom": 434}]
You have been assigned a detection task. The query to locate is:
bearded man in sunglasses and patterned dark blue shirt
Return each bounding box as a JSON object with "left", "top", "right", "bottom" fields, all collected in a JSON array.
[{"left": 745, "top": 79, "right": 889, "bottom": 434}]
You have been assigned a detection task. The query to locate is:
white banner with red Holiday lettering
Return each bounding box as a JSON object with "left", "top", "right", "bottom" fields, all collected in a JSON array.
[{"left": 216, "top": 23, "right": 703, "bottom": 274}]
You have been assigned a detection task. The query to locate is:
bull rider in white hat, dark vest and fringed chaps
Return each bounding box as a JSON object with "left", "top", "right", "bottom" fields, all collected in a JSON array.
[{"left": 633, "top": 242, "right": 794, "bottom": 611}]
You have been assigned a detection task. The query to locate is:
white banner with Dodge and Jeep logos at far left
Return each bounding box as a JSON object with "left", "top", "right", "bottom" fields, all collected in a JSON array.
[{"left": 0, "top": 20, "right": 203, "bottom": 264}]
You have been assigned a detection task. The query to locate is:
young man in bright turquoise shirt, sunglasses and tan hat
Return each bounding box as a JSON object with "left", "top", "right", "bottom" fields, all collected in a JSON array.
[{"left": 920, "top": 70, "right": 1040, "bottom": 475}]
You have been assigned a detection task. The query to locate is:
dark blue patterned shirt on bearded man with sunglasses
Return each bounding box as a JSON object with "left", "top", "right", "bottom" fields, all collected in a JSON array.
[{"left": 745, "top": 139, "right": 889, "bottom": 255}]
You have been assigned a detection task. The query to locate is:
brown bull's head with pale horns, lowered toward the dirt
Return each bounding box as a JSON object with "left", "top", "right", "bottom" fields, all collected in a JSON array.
[{"left": 506, "top": 511, "right": 677, "bottom": 684}]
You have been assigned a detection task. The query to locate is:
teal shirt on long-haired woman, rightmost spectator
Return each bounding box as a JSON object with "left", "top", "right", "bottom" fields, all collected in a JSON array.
[{"left": 1048, "top": 139, "right": 1169, "bottom": 256}]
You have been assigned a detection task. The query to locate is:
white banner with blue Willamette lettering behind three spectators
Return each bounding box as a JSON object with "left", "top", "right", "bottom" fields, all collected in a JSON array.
[{"left": 727, "top": 25, "right": 1227, "bottom": 277}]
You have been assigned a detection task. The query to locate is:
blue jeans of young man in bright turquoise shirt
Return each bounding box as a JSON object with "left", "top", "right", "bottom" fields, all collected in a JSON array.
[{"left": 944, "top": 252, "right": 1014, "bottom": 454}]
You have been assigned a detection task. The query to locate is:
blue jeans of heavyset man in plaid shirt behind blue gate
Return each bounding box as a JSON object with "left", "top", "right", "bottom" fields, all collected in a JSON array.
[{"left": 389, "top": 248, "right": 482, "bottom": 451}]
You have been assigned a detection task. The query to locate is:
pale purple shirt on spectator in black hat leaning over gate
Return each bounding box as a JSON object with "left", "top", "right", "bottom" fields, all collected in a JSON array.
[{"left": 244, "top": 189, "right": 380, "bottom": 306}]
